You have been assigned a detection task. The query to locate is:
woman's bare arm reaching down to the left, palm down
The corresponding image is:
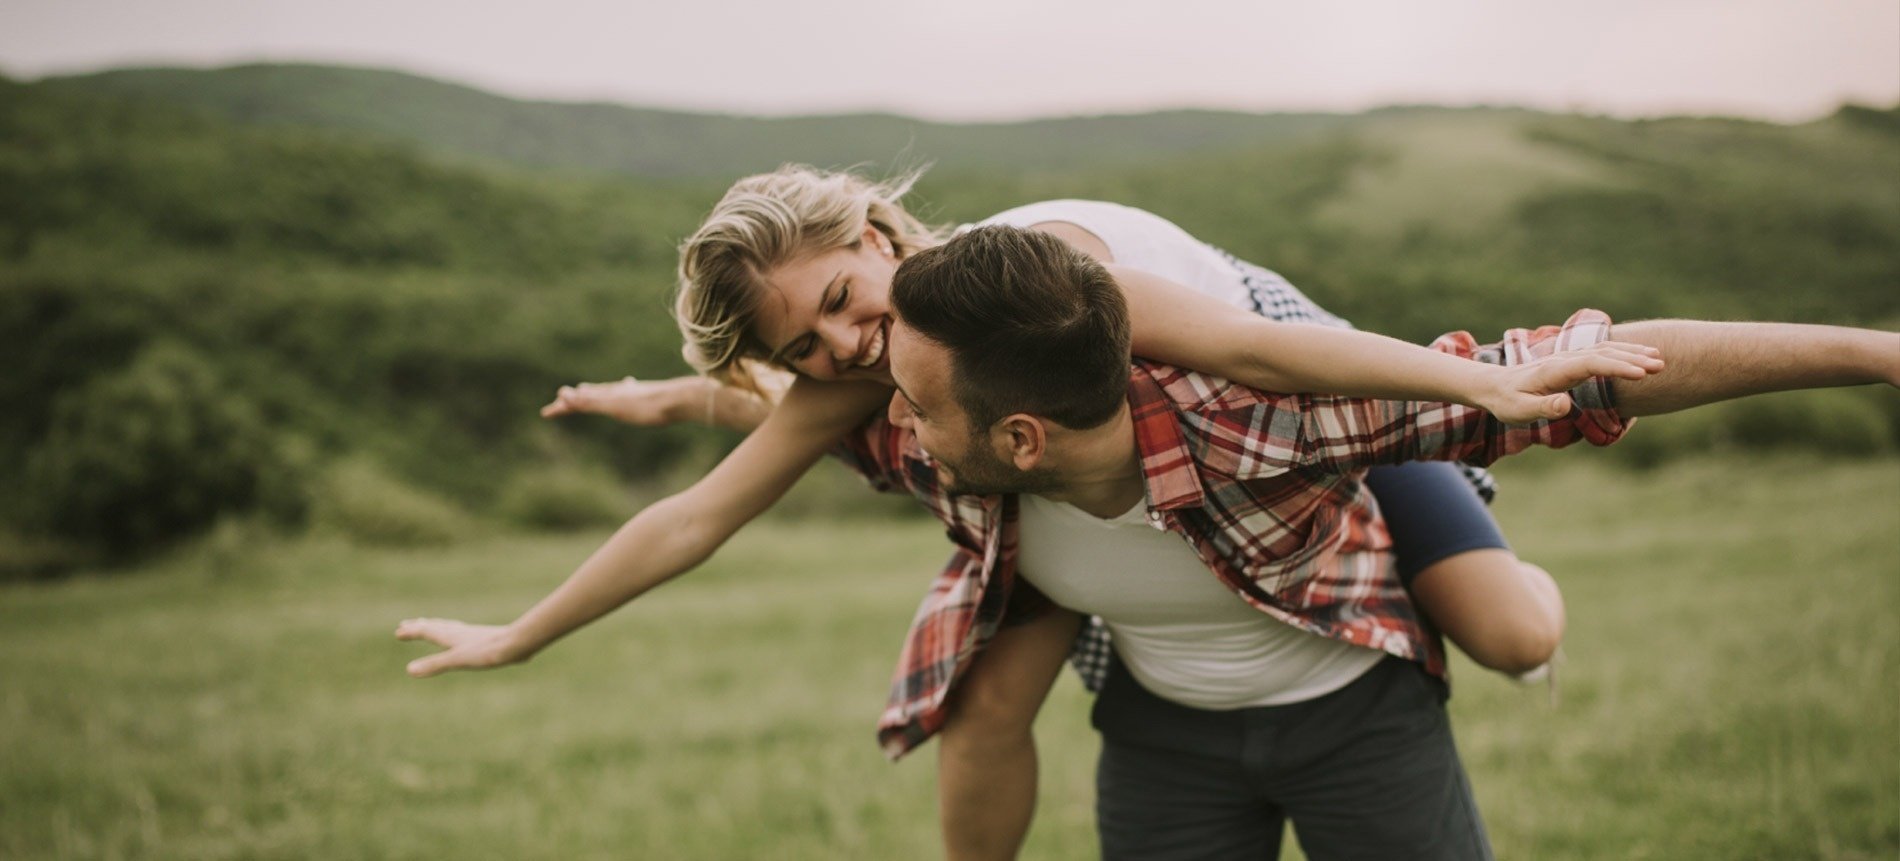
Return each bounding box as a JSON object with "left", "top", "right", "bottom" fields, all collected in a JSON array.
[{"left": 395, "top": 380, "right": 891, "bottom": 679}]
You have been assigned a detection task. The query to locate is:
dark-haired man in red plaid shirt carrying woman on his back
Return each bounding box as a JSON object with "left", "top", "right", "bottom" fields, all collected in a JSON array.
[{"left": 849, "top": 228, "right": 1900, "bottom": 859}]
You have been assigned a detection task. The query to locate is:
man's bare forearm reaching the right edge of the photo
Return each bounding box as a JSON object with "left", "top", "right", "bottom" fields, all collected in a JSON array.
[{"left": 1611, "top": 319, "right": 1900, "bottom": 418}]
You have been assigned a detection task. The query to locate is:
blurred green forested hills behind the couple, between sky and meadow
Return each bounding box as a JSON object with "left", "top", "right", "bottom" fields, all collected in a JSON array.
[{"left": 0, "top": 67, "right": 1900, "bottom": 574}]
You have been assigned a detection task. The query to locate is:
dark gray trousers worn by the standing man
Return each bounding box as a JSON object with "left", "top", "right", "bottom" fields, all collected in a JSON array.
[{"left": 1093, "top": 658, "right": 1492, "bottom": 861}]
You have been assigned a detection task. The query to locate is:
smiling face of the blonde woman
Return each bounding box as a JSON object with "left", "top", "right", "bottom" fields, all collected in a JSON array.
[{"left": 754, "top": 224, "right": 897, "bottom": 382}]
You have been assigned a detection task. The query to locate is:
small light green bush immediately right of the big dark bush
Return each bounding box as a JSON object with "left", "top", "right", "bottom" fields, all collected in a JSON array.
[{"left": 312, "top": 458, "right": 475, "bottom": 547}]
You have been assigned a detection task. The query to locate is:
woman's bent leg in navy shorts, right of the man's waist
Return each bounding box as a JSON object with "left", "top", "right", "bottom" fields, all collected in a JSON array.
[{"left": 1366, "top": 462, "right": 1564, "bottom": 675}]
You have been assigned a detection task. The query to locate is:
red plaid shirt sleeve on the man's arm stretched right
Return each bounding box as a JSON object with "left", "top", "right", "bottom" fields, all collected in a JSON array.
[{"left": 1189, "top": 310, "right": 1632, "bottom": 479}]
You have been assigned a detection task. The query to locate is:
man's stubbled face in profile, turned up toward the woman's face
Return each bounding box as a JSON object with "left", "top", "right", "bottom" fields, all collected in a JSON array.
[{"left": 889, "top": 319, "right": 1055, "bottom": 496}]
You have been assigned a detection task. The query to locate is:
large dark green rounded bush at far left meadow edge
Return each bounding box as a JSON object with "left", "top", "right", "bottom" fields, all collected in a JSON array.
[{"left": 25, "top": 342, "right": 304, "bottom": 555}]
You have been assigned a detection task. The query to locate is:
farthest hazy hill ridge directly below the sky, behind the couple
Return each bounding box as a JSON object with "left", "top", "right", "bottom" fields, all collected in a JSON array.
[{"left": 49, "top": 65, "right": 1345, "bottom": 177}]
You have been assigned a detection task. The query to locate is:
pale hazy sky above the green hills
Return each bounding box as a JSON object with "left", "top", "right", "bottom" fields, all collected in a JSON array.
[{"left": 0, "top": 0, "right": 1900, "bottom": 120}]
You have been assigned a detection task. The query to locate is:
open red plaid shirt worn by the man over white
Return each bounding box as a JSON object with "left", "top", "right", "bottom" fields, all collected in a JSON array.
[{"left": 842, "top": 310, "right": 1628, "bottom": 758}]
